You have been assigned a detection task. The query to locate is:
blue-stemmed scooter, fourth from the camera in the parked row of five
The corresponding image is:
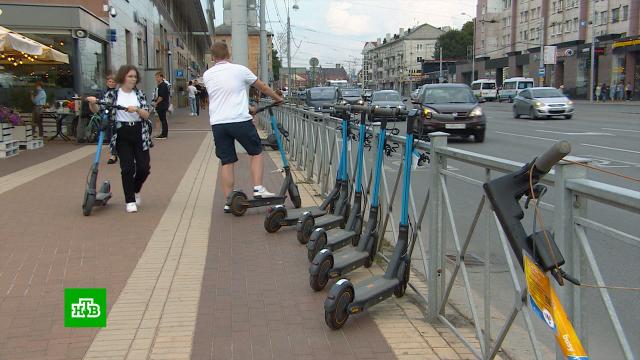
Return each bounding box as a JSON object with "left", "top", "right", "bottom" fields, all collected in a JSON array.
[{"left": 296, "top": 105, "right": 356, "bottom": 244}]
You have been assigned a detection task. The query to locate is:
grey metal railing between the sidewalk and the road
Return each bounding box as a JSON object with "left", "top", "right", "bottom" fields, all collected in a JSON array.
[{"left": 260, "top": 105, "right": 640, "bottom": 359}]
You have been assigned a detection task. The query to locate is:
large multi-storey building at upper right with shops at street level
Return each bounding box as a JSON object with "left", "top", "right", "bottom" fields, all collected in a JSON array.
[{"left": 457, "top": 0, "right": 640, "bottom": 98}]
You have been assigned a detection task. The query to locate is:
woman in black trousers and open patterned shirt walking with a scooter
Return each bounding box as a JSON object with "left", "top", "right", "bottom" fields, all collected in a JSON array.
[{"left": 87, "top": 65, "right": 151, "bottom": 213}]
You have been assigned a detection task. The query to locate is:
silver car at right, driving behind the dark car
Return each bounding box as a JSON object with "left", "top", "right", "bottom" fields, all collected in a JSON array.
[{"left": 513, "top": 87, "right": 575, "bottom": 119}]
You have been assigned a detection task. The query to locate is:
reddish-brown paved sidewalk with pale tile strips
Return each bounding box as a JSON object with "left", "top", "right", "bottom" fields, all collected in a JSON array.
[{"left": 0, "top": 108, "right": 473, "bottom": 359}]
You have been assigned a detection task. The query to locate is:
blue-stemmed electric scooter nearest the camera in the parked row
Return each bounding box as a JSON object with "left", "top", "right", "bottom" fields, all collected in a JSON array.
[{"left": 324, "top": 109, "right": 453, "bottom": 330}]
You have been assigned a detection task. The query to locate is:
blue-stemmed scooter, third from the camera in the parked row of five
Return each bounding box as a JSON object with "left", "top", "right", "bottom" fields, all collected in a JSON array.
[{"left": 307, "top": 105, "right": 387, "bottom": 261}]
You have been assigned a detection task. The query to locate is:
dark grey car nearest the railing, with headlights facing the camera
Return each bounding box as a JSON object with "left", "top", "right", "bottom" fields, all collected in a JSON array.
[{"left": 418, "top": 83, "right": 487, "bottom": 142}]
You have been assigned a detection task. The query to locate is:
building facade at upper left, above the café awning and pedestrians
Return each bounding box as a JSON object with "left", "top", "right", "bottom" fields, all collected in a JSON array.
[{"left": 0, "top": 0, "right": 213, "bottom": 106}]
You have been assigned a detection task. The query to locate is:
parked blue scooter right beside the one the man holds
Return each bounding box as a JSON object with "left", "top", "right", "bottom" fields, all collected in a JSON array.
[{"left": 264, "top": 105, "right": 349, "bottom": 238}]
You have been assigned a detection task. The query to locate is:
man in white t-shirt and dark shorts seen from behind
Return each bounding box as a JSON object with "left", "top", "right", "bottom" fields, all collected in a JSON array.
[{"left": 203, "top": 42, "right": 283, "bottom": 212}]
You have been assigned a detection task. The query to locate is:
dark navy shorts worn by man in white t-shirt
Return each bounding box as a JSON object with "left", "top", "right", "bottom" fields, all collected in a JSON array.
[{"left": 211, "top": 120, "right": 262, "bottom": 165}]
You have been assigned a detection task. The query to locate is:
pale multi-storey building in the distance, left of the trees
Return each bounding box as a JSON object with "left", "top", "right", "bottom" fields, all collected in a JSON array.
[{"left": 368, "top": 24, "right": 444, "bottom": 96}]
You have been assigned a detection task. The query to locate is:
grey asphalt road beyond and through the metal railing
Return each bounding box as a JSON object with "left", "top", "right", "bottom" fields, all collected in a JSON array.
[{"left": 350, "top": 103, "right": 640, "bottom": 358}]
